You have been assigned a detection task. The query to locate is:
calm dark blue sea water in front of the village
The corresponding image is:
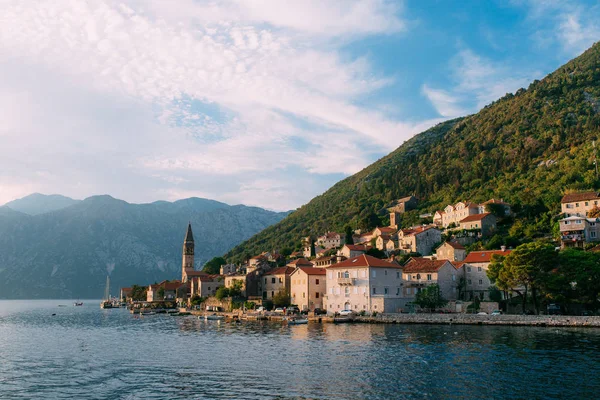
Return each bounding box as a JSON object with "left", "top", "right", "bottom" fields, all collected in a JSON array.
[{"left": 0, "top": 301, "right": 600, "bottom": 399}]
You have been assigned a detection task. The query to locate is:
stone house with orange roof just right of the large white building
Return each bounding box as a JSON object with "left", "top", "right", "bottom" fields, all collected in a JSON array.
[{"left": 402, "top": 257, "right": 463, "bottom": 300}]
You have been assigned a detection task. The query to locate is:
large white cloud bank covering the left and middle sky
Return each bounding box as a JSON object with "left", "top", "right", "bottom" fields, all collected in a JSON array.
[{"left": 0, "top": 0, "right": 428, "bottom": 209}]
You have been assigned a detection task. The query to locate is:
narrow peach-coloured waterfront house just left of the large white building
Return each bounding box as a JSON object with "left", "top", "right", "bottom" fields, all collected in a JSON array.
[{"left": 290, "top": 267, "right": 326, "bottom": 311}]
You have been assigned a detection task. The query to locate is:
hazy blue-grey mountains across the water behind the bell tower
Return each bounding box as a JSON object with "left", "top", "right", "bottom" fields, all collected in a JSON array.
[{"left": 0, "top": 196, "right": 287, "bottom": 298}]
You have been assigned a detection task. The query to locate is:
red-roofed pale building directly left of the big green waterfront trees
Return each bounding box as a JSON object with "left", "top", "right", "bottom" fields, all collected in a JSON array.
[{"left": 463, "top": 248, "right": 510, "bottom": 300}]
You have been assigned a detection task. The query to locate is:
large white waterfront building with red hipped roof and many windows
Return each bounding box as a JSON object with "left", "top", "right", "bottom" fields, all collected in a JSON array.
[{"left": 325, "top": 254, "right": 406, "bottom": 314}]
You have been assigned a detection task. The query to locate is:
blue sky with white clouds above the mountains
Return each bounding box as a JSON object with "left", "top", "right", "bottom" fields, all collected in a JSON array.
[{"left": 0, "top": 0, "right": 600, "bottom": 211}]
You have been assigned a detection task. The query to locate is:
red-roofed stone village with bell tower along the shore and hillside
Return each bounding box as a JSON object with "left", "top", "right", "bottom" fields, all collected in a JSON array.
[{"left": 121, "top": 192, "right": 600, "bottom": 315}]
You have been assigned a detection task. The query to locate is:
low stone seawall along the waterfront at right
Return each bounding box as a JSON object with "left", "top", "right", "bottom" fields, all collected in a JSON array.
[{"left": 354, "top": 314, "right": 600, "bottom": 328}]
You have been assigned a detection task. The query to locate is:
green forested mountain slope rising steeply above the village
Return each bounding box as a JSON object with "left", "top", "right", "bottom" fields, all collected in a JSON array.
[{"left": 226, "top": 43, "right": 600, "bottom": 261}]
